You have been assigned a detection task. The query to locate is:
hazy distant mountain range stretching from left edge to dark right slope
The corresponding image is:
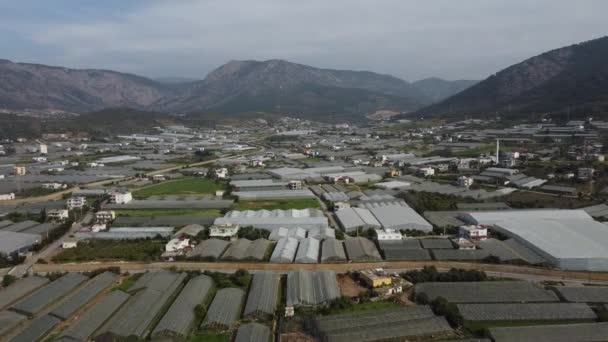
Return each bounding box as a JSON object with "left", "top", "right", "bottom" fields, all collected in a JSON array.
[{"left": 0, "top": 60, "right": 476, "bottom": 117}]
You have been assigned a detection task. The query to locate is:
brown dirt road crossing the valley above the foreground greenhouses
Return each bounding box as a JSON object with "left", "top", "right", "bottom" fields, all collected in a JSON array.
[{"left": 33, "top": 261, "right": 608, "bottom": 282}]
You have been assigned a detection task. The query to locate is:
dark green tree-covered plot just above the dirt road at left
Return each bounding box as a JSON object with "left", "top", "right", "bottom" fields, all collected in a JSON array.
[{"left": 53, "top": 240, "right": 165, "bottom": 262}]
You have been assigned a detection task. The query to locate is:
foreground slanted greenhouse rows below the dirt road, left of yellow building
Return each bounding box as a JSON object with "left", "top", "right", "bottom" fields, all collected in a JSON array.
[{"left": 0, "top": 270, "right": 340, "bottom": 341}]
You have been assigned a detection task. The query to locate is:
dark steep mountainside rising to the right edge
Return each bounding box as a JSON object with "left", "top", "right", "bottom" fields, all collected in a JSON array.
[{"left": 415, "top": 37, "right": 608, "bottom": 119}]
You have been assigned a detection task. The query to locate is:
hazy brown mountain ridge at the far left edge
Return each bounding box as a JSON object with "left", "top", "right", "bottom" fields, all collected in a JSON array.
[{"left": 0, "top": 60, "right": 171, "bottom": 111}]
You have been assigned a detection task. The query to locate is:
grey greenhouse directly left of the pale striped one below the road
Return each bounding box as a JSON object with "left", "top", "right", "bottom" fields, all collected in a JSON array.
[{"left": 243, "top": 272, "right": 279, "bottom": 319}]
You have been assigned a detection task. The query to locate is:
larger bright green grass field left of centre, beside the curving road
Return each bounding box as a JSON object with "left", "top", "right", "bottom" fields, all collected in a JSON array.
[{"left": 133, "top": 177, "right": 224, "bottom": 198}]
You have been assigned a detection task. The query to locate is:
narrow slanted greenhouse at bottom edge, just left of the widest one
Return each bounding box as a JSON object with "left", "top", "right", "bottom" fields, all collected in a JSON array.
[{"left": 61, "top": 291, "right": 130, "bottom": 341}]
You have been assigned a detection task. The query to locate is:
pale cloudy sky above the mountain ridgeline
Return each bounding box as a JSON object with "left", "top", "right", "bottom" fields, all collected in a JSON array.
[{"left": 0, "top": 0, "right": 608, "bottom": 81}]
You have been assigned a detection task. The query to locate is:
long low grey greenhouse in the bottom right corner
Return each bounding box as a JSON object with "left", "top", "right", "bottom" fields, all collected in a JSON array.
[{"left": 489, "top": 322, "right": 608, "bottom": 342}]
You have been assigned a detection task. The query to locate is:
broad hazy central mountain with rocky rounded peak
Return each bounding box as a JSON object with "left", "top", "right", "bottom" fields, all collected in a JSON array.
[{"left": 157, "top": 60, "right": 430, "bottom": 118}]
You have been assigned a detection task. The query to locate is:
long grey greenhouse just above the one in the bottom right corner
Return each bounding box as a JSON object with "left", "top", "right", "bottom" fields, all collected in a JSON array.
[{"left": 456, "top": 303, "right": 597, "bottom": 323}]
